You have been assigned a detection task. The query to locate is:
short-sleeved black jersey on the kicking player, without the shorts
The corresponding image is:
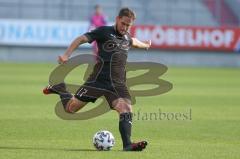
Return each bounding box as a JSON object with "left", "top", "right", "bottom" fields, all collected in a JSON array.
[{"left": 84, "top": 26, "right": 132, "bottom": 85}]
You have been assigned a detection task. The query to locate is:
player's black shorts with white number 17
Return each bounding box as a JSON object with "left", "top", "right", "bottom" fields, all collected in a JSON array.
[{"left": 75, "top": 62, "right": 131, "bottom": 108}]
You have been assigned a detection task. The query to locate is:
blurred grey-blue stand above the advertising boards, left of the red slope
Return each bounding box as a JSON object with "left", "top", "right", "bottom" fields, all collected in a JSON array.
[{"left": 0, "top": 0, "right": 217, "bottom": 26}]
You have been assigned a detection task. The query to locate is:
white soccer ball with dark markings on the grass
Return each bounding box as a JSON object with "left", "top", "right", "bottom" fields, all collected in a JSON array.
[{"left": 93, "top": 130, "right": 115, "bottom": 151}]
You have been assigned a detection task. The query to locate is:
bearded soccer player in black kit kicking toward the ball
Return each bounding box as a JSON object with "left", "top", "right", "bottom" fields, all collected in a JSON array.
[{"left": 43, "top": 8, "right": 151, "bottom": 151}]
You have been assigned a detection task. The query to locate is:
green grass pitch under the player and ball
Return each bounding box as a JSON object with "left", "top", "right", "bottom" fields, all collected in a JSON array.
[{"left": 0, "top": 63, "right": 240, "bottom": 159}]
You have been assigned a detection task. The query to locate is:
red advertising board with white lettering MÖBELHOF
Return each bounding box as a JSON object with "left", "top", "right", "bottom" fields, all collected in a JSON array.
[{"left": 130, "top": 25, "right": 240, "bottom": 51}]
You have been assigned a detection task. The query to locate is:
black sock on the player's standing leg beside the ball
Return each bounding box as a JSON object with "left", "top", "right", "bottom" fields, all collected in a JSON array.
[{"left": 119, "top": 112, "right": 132, "bottom": 148}]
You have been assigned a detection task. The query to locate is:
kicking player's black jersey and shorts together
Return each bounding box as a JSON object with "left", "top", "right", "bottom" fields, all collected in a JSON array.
[{"left": 75, "top": 26, "right": 132, "bottom": 105}]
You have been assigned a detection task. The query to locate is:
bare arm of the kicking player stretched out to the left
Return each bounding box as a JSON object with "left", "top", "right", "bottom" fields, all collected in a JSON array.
[{"left": 58, "top": 35, "right": 89, "bottom": 64}]
